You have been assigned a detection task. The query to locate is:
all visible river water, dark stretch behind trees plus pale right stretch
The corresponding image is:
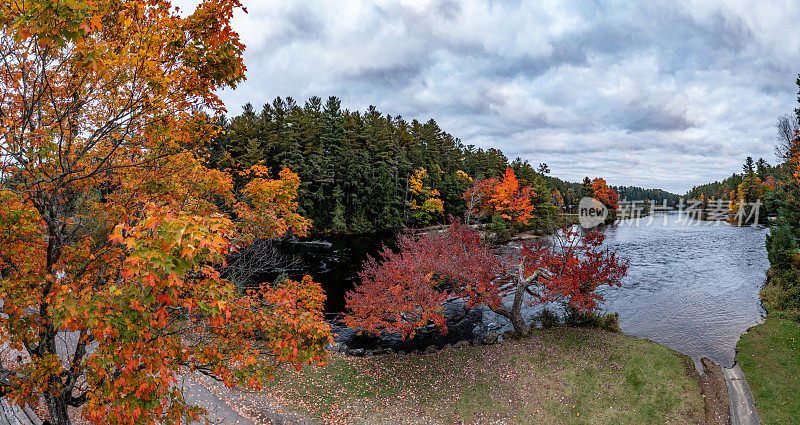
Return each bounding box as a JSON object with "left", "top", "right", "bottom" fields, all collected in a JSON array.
[{"left": 266, "top": 213, "right": 769, "bottom": 366}]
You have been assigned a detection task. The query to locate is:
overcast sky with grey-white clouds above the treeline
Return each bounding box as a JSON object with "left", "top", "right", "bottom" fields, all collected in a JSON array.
[{"left": 177, "top": 0, "right": 800, "bottom": 194}]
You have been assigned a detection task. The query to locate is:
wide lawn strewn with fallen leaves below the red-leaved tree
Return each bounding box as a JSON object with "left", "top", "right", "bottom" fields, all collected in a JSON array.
[{"left": 265, "top": 328, "right": 703, "bottom": 424}]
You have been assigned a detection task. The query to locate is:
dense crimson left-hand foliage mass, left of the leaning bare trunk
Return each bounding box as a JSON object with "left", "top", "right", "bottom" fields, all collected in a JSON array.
[{"left": 345, "top": 224, "right": 502, "bottom": 336}]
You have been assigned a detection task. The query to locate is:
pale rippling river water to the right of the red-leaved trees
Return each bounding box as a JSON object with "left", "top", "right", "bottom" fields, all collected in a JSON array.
[{"left": 605, "top": 213, "right": 769, "bottom": 367}]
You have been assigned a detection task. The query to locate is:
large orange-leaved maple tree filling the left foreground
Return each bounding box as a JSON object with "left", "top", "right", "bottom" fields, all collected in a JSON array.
[{"left": 0, "top": 0, "right": 330, "bottom": 425}]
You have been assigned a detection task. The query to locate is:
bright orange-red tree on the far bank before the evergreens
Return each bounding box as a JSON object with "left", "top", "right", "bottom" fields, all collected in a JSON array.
[{"left": 463, "top": 167, "right": 535, "bottom": 227}]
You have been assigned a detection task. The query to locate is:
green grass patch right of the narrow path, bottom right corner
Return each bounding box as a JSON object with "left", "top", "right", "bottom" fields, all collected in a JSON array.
[{"left": 736, "top": 317, "right": 800, "bottom": 425}]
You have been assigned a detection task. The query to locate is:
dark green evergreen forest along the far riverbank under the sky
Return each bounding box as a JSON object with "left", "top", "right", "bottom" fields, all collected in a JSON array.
[{"left": 208, "top": 96, "right": 678, "bottom": 233}]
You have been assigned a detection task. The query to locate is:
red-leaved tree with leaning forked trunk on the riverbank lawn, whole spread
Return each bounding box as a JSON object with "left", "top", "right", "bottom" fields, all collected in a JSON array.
[{"left": 344, "top": 222, "right": 628, "bottom": 337}]
